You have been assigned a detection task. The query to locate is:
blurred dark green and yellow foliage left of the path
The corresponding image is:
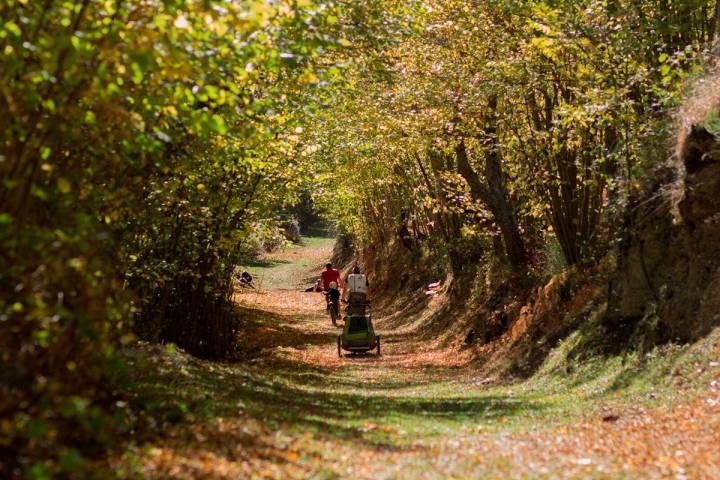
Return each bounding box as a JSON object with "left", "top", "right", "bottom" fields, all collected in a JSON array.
[{"left": 0, "top": 0, "right": 344, "bottom": 478}]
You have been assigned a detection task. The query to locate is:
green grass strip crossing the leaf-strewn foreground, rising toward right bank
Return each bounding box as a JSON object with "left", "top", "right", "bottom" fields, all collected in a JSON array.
[{"left": 122, "top": 331, "right": 720, "bottom": 446}]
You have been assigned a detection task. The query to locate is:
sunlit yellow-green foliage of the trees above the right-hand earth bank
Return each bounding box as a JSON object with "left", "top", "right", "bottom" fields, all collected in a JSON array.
[{"left": 307, "top": 0, "right": 715, "bottom": 272}]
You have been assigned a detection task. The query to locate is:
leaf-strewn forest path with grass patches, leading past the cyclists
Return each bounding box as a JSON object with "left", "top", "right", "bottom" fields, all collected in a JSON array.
[{"left": 126, "top": 238, "right": 720, "bottom": 479}]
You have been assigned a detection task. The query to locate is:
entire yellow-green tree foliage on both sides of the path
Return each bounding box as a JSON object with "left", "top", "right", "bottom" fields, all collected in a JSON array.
[{"left": 0, "top": 0, "right": 717, "bottom": 478}]
